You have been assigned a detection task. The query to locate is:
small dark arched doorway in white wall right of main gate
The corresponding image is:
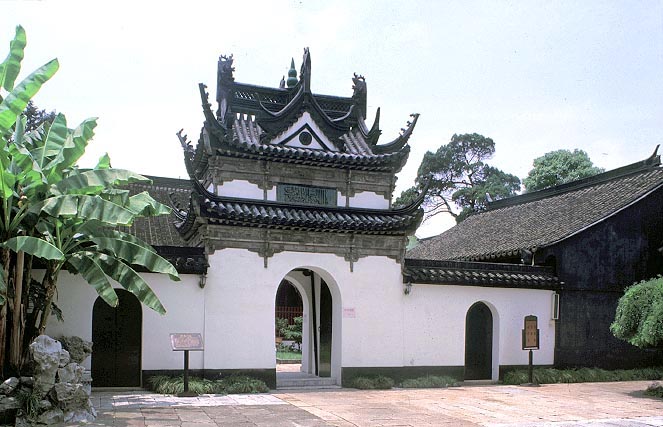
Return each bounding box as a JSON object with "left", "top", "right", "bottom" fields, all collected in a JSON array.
[{"left": 465, "top": 302, "right": 493, "bottom": 380}]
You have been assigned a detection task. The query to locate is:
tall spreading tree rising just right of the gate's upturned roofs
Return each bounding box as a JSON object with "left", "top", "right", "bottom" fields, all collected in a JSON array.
[{"left": 395, "top": 133, "right": 520, "bottom": 222}]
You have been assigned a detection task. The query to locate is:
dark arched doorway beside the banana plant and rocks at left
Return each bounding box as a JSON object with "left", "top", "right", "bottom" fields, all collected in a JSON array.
[{"left": 92, "top": 289, "right": 143, "bottom": 387}]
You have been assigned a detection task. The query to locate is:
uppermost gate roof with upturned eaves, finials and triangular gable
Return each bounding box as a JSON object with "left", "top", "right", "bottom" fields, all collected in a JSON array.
[{"left": 180, "top": 50, "right": 418, "bottom": 179}]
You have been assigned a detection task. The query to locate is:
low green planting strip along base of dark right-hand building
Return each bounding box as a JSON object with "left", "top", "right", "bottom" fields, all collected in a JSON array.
[{"left": 503, "top": 367, "right": 663, "bottom": 385}]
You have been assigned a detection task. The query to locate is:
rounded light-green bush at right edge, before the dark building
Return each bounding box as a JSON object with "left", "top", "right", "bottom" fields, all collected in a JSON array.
[{"left": 610, "top": 276, "right": 663, "bottom": 348}]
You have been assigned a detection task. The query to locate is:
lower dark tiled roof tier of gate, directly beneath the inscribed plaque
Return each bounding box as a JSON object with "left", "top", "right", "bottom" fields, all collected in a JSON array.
[{"left": 200, "top": 197, "right": 423, "bottom": 234}]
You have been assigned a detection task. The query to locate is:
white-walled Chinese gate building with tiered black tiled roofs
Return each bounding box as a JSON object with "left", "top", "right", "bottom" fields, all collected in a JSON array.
[{"left": 49, "top": 50, "right": 558, "bottom": 386}]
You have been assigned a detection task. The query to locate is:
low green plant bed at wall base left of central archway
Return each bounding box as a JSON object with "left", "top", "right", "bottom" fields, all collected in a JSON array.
[{"left": 148, "top": 375, "right": 269, "bottom": 394}]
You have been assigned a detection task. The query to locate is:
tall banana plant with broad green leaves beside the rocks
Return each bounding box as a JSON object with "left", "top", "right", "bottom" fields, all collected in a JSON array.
[{"left": 0, "top": 26, "right": 179, "bottom": 373}]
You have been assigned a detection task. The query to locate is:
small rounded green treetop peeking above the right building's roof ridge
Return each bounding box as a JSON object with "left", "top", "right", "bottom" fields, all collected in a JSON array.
[{"left": 523, "top": 149, "right": 603, "bottom": 192}]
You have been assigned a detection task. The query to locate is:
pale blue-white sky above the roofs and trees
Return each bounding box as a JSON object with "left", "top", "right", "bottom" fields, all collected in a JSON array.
[{"left": 0, "top": 1, "right": 663, "bottom": 236}]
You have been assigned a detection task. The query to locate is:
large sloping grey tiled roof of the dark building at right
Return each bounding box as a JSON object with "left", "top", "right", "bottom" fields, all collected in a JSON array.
[{"left": 406, "top": 155, "right": 663, "bottom": 261}]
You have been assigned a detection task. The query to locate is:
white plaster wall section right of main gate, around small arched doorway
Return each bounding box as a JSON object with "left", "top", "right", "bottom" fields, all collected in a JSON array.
[{"left": 403, "top": 284, "right": 555, "bottom": 378}]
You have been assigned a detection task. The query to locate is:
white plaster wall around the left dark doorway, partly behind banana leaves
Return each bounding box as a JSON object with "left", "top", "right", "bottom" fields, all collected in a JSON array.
[{"left": 46, "top": 272, "right": 205, "bottom": 370}]
